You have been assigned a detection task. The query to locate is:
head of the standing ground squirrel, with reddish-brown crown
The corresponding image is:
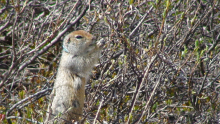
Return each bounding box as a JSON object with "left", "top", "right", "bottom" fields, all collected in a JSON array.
[{"left": 63, "top": 30, "right": 104, "bottom": 55}]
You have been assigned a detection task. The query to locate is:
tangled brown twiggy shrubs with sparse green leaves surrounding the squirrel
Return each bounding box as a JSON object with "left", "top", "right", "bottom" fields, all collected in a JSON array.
[{"left": 0, "top": 0, "right": 220, "bottom": 123}]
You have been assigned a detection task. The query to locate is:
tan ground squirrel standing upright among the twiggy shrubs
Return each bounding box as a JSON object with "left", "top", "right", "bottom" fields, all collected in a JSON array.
[{"left": 45, "top": 30, "right": 104, "bottom": 124}]
